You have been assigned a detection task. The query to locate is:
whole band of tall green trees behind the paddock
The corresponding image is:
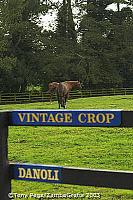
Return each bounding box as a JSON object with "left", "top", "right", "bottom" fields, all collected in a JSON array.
[{"left": 0, "top": 0, "right": 133, "bottom": 92}]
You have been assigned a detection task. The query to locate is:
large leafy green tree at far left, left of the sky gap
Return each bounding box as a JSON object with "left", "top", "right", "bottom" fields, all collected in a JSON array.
[{"left": 0, "top": 0, "right": 48, "bottom": 92}]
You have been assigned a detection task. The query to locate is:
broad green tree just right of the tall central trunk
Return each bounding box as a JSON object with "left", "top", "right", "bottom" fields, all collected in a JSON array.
[{"left": 76, "top": 0, "right": 131, "bottom": 87}]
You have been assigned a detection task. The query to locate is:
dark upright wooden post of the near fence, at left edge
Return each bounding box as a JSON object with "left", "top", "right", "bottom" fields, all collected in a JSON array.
[{"left": 0, "top": 112, "right": 11, "bottom": 200}]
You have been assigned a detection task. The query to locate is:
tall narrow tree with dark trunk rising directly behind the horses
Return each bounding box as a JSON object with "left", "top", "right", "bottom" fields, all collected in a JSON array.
[{"left": 40, "top": 0, "right": 77, "bottom": 82}]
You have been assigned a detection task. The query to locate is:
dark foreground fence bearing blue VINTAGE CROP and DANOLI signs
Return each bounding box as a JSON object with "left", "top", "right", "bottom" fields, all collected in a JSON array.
[{"left": 0, "top": 110, "right": 133, "bottom": 200}]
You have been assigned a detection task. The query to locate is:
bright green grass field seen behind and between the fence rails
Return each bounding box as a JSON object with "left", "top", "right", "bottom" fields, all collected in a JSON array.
[{"left": 0, "top": 96, "right": 133, "bottom": 200}]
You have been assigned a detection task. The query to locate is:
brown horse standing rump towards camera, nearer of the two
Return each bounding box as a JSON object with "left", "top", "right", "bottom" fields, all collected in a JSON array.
[{"left": 57, "top": 81, "right": 81, "bottom": 108}]
